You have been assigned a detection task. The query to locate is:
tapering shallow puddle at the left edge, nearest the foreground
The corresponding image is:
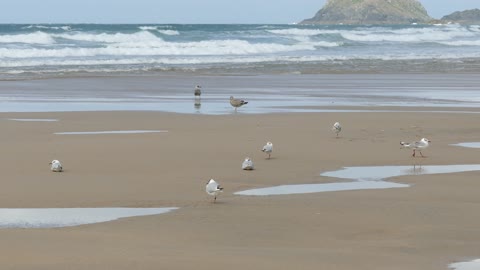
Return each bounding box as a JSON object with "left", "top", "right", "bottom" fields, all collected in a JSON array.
[{"left": 0, "top": 207, "right": 177, "bottom": 228}]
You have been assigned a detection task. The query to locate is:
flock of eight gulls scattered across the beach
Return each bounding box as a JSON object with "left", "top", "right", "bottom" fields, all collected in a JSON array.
[{"left": 50, "top": 85, "right": 430, "bottom": 202}]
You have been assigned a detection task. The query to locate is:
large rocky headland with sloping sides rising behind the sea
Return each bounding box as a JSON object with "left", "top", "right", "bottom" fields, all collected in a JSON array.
[{"left": 300, "top": 0, "right": 432, "bottom": 24}]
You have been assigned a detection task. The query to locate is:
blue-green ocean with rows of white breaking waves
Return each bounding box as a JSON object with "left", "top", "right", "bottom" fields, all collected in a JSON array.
[{"left": 0, "top": 24, "right": 480, "bottom": 80}]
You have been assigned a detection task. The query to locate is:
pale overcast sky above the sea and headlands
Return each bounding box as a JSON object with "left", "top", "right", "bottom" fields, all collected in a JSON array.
[{"left": 0, "top": 0, "right": 480, "bottom": 24}]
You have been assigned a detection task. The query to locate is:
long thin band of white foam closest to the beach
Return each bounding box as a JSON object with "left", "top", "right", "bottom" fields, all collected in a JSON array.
[{"left": 0, "top": 49, "right": 480, "bottom": 69}]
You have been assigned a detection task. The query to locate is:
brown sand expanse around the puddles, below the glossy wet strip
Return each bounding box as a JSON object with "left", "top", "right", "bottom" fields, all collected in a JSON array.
[{"left": 0, "top": 112, "right": 480, "bottom": 270}]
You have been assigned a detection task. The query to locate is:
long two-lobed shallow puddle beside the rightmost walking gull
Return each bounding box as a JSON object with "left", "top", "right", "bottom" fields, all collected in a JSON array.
[{"left": 235, "top": 164, "right": 480, "bottom": 196}]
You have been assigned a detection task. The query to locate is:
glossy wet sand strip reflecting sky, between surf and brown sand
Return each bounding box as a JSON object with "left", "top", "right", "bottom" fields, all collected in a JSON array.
[{"left": 0, "top": 74, "right": 480, "bottom": 115}]
